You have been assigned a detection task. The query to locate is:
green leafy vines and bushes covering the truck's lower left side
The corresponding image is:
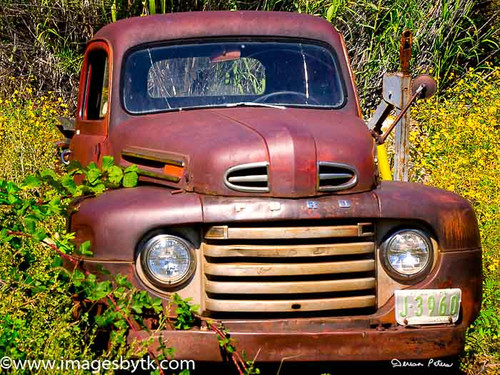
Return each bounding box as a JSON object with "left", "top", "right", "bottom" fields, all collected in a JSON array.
[{"left": 0, "top": 152, "right": 259, "bottom": 375}]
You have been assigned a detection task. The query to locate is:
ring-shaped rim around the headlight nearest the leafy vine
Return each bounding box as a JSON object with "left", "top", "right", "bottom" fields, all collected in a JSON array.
[{"left": 139, "top": 232, "right": 197, "bottom": 293}]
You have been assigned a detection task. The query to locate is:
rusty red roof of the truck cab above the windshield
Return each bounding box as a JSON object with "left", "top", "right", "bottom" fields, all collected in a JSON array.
[{"left": 93, "top": 11, "right": 340, "bottom": 56}]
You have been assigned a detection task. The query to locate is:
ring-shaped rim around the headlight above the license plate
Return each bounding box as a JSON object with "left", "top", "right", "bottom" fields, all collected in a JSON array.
[{"left": 379, "top": 228, "right": 435, "bottom": 284}]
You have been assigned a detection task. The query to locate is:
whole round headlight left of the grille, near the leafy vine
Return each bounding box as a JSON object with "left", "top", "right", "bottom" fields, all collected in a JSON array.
[{"left": 137, "top": 234, "right": 195, "bottom": 289}]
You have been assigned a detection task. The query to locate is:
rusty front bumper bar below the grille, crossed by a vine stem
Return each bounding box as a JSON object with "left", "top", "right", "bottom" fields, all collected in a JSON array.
[{"left": 131, "top": 323, "right": 466, "bottom": 362}]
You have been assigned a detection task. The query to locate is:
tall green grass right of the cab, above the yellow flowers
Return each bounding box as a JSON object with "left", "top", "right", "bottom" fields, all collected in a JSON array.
[{"left": 318, "top": 0, "right": 499, "bottom": 109}]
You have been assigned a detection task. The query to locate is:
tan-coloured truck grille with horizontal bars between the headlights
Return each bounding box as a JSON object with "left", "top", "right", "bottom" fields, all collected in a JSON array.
[{"left": 202, "top": 223, "right": 376, "bottom": 315}]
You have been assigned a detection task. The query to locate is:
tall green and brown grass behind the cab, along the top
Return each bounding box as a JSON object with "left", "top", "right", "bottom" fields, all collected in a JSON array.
[{"left": 0, "top": 0, "right": 500, "bottom": 110}]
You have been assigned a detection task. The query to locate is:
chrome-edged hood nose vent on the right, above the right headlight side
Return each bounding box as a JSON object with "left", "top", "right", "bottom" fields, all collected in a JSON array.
[{"left": 318, "top": 161, "right": 358, "bottom": 191}]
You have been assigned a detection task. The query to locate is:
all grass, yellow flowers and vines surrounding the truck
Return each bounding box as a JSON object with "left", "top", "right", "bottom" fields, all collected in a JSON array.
[{"left": 0, "top": 0, "right": 500, "bottom": 374}]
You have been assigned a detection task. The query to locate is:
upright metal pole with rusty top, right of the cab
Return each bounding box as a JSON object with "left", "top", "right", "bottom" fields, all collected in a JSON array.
[{"left": 394, "top": 30, "right": 412, "bottom": 181}]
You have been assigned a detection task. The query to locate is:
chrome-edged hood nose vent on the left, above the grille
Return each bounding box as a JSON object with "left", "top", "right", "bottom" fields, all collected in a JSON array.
[{"left": 224, "top": 162, "right": 269, "bottom": 193}]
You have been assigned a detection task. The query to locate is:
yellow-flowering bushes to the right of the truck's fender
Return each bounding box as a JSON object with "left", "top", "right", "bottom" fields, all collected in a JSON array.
[{"left": 411, "top": 67, "right": 500, "bottom": 374}]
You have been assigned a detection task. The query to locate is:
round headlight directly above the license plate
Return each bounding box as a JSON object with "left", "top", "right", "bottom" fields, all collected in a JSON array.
[{"left": 381, "top": 229, "right": 432, "bottom": 281}]
